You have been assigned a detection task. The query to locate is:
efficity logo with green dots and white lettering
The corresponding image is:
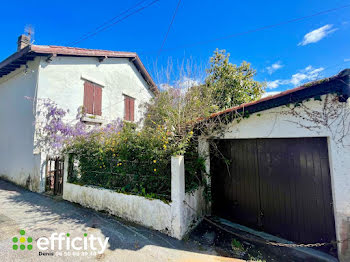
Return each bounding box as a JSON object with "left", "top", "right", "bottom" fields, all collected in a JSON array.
[{"left": 12, "top": 229, "right": 109, "bottom": 256}]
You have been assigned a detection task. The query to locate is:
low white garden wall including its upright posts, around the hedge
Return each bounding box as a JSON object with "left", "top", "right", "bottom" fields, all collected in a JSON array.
[{"left": 63, "top": 156, "right": 206, "bottom": 239}]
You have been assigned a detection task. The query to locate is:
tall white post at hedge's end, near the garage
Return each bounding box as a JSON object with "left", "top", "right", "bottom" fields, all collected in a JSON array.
[{"left": 171, "top": 156, "right": 186, "bottom": 239}]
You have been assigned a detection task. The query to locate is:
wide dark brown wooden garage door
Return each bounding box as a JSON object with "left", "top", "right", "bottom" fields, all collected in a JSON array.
[{"left": 211, "top": 138, "right": 336, "bottom": 253}]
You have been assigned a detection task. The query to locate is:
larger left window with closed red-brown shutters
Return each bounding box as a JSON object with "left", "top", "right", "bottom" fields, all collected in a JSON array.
[{"left": 84, "top": 81, "right": 102, "bottom": 116}]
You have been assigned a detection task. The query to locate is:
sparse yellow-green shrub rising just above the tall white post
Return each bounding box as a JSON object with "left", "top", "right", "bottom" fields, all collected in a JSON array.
[{"left": 144, "top": 86, "right": 216, "bottom": 154}]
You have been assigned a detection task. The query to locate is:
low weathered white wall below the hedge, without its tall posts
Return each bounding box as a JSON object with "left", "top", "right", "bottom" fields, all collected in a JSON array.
[{"left": 63, "top": 182, "right": 205, "bottom": 239}]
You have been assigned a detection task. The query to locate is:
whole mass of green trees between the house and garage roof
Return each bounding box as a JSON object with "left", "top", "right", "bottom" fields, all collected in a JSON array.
[{"left": 144, "top": 50, "right": 265, "bottom": 151}]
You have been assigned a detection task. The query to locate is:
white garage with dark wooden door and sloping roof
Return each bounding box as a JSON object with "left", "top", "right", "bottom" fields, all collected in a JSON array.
[{"left": 199, "top": 69, "right": 350, "bottom": 261}]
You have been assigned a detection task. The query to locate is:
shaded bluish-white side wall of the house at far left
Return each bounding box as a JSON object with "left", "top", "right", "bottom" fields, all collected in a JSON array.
[{"left": 0, "top": 59, "right": 40, "bottom": 191}]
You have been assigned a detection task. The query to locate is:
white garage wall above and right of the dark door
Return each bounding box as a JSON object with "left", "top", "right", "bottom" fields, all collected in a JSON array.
[{"left": 199, "top": 96, "right": 350, "bottom": 261}]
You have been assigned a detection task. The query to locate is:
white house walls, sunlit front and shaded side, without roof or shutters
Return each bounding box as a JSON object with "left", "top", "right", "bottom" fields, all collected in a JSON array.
[{"left": 0, "top": 54, "right": 153, "bottom": 192}]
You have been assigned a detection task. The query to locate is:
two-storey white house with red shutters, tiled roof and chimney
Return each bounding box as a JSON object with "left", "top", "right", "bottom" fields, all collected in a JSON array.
[{"left": 0, "top": 35, "right": 157, "bottom": 192}]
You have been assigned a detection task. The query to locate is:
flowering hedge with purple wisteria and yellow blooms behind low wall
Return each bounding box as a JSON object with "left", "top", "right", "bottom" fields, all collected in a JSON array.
[{"left": 37, "top": 99, "right": 204, "bottom": 200}]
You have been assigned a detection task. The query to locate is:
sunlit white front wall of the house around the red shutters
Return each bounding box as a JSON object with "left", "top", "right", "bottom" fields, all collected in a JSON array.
[{"left": 38, "top": 56, "right": 153, "bottom": 125}]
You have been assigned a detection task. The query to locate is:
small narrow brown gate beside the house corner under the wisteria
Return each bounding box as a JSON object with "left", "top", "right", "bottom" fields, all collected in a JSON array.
[{"left": 45, "top": 157, "right": 64, "bottom": 195}]
